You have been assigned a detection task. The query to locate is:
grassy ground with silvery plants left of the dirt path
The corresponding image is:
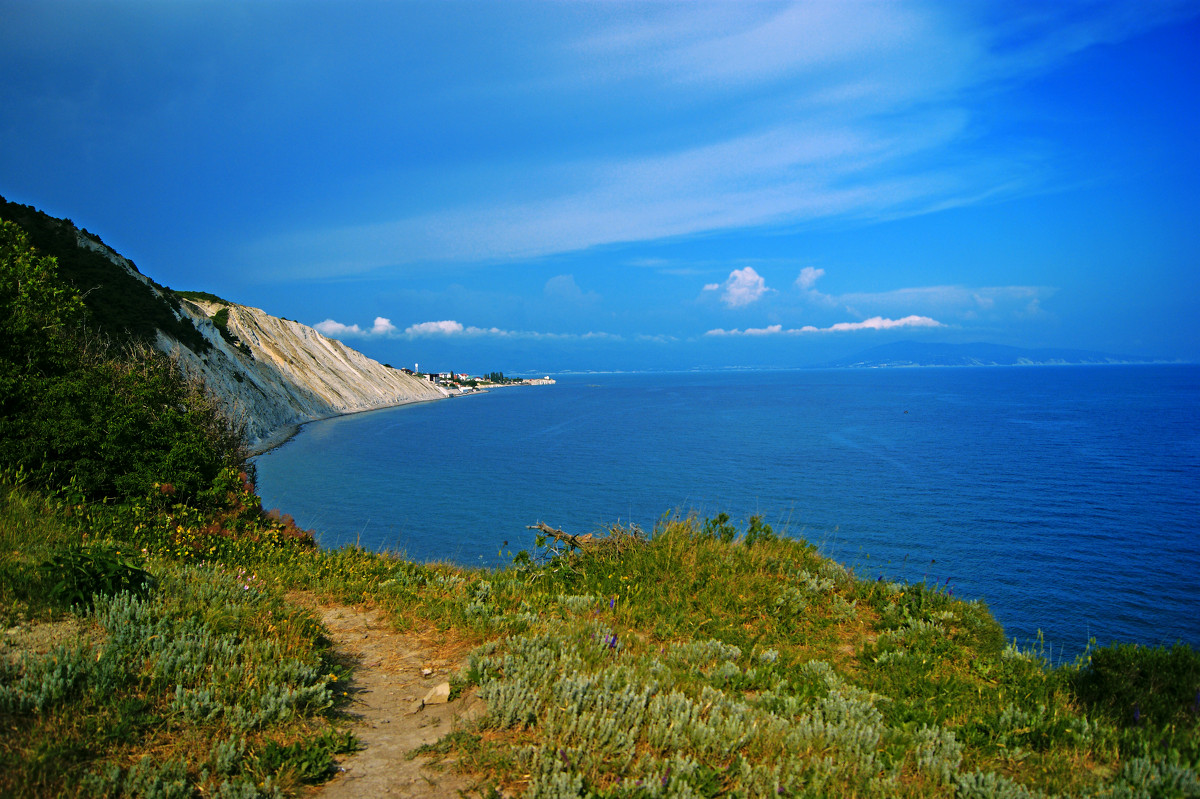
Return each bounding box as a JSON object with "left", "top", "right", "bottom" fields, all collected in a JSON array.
[{"left": 0, "top": 481, "right": 354, "bottom": 797}]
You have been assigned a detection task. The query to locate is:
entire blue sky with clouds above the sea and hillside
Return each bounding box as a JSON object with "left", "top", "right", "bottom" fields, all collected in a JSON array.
[{"left": 0, "top": 0, "right": 1200, "bottom": 373}]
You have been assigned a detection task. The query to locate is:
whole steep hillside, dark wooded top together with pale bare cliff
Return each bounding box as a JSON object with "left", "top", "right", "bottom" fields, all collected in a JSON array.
[{"left": 0, "top": 198, "right": 446, "bottom": 447}]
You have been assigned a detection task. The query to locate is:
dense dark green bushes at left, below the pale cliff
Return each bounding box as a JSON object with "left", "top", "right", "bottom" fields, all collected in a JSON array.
[{"left": 0, "top": 222, "right": 246, "bottom": 500}]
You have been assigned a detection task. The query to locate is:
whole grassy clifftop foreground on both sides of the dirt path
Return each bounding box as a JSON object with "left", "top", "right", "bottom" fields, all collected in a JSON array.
[{"left": 0, "top": 480, "right": 1200, "bottom": 798}]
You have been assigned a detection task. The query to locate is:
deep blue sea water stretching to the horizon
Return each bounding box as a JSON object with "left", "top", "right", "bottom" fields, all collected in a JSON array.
[{"left": 257, "top": 366, "right": 1200, "bottom": 660}]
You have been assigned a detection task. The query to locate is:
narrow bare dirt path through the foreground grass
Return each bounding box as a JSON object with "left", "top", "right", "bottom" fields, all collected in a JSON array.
[{"left": 302, "top": 602, "right": 485, "bottom": 799}]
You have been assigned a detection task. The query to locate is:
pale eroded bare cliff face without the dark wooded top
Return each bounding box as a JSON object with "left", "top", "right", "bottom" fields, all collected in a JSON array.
[{"left": 158, "top": 300, "right": 448, "bottom": 450}]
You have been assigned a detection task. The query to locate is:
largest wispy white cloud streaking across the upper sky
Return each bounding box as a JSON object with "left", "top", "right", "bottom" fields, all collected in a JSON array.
[{"left": 246, "top": 2, "right": 1188, "bottom": 276}]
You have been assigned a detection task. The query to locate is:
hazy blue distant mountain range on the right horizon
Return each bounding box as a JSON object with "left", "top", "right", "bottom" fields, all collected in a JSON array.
[{"left": 822, "top": 341, "right": 1154, "bottom": 368}]
